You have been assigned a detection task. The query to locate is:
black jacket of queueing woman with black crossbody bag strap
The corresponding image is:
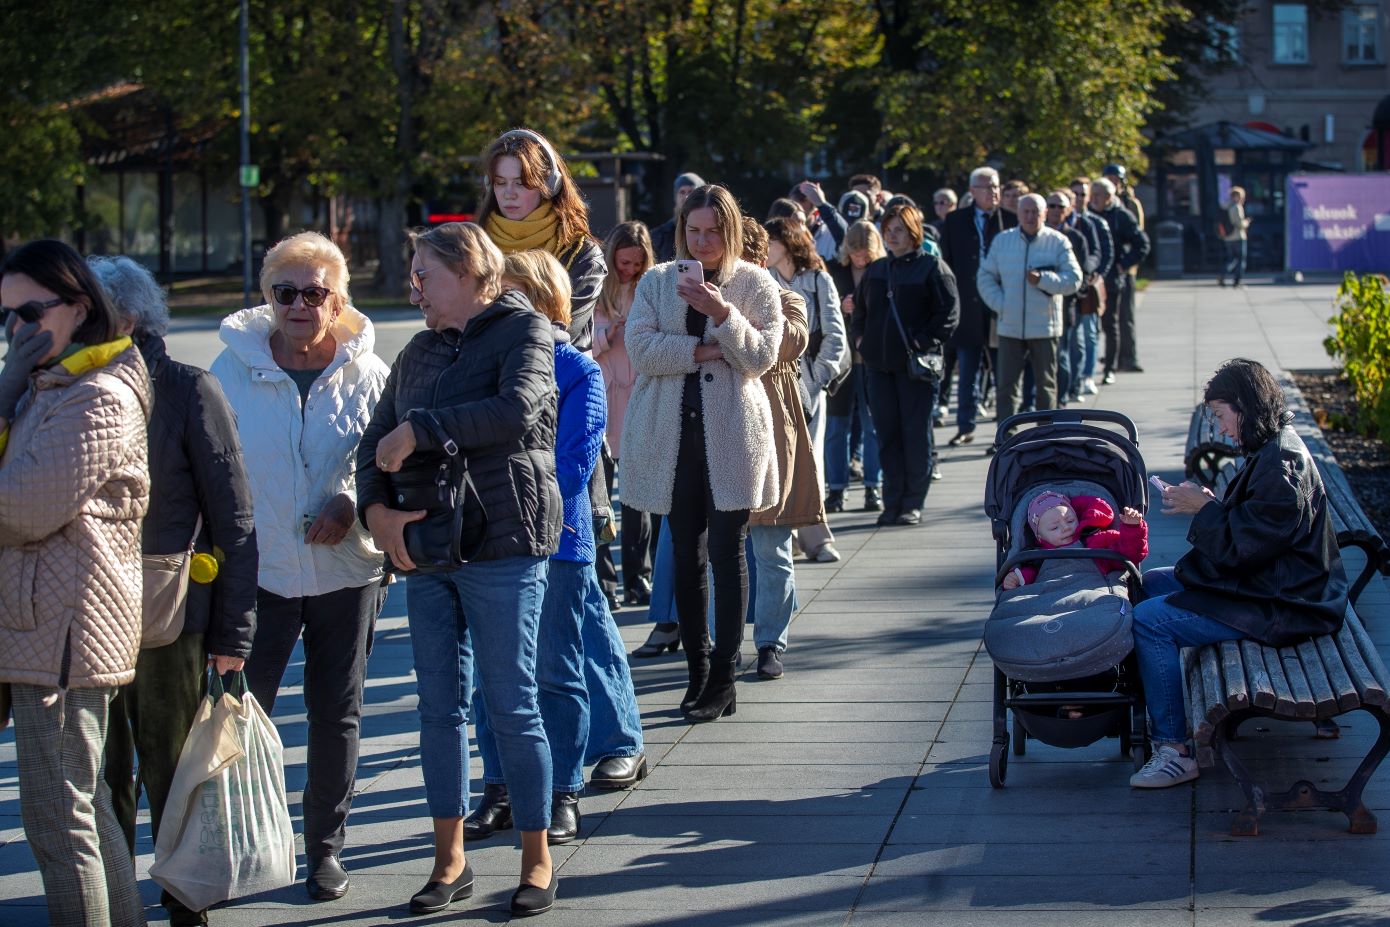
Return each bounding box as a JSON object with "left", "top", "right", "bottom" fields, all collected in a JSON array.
[{"left": 849, "top": 249, "right": 960, "bottom": 374}]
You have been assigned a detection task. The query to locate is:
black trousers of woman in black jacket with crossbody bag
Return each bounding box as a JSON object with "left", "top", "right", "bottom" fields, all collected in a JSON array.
[{"left": 865, "top": 367, "right": 937, "bottom": 516}]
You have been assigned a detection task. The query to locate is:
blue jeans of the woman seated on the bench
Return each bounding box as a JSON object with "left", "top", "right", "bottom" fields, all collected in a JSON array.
[{"left": 1134, "top": 567, "right": 1245, "bottom": 744}]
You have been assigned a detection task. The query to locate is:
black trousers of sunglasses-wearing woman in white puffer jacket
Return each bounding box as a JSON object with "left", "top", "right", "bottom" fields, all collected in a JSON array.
[{"left": 246, "top": 582, "right": 385, "bottom": 859}]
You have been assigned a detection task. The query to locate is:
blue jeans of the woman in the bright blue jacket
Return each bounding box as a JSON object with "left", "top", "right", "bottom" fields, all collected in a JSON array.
[{"left": 473, "top": 560, "right": 589, "bottom": 792}]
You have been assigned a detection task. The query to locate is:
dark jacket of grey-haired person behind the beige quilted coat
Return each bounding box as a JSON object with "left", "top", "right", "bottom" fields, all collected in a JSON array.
[{"left": 139, "top": 335, "right": 260, "bottom": 657}]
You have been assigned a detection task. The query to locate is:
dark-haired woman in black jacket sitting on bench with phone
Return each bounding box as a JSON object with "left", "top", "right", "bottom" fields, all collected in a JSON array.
[{"left": 1130, "top": 359, "right": 1347, "bottom": 788}]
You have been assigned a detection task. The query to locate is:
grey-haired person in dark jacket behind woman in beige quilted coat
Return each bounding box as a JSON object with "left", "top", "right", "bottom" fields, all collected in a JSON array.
[{"left": 92, "top": 257, "right": 260, "bottom": 924}]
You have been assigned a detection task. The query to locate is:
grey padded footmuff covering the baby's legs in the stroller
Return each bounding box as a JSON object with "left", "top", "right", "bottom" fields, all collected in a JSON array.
[{"left": 984, "top": 550, "right": 1134, "bottom": 682}]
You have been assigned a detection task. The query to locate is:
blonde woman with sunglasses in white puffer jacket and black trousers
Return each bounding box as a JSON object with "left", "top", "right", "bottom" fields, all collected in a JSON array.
[{"left": 213, "top": 232, "right": 389, "bottom": 901}]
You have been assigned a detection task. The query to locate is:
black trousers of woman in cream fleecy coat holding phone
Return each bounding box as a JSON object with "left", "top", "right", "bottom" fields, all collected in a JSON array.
[{"left": 667, "top": 409, "right": 748, "bottom": 667}]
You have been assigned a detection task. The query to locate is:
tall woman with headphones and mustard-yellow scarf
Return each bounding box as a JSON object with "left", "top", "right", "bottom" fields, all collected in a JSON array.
[{"left": 478, "top": 129, "right": 607, "bottom": 352}]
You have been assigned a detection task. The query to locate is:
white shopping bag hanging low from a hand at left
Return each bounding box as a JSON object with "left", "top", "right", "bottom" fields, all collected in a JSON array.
[{"left": 150, "top": 674, "right": 295, "bottom": 910}]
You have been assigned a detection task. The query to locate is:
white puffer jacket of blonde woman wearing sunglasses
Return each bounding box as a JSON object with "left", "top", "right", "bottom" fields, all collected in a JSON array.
[{"left": 211, "top": 306, "right": 391, "bottom": 598}]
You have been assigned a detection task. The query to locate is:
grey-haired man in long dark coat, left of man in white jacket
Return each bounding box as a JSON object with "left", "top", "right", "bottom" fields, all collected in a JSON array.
[{"left": 940, "top": 167, "right": 1019, "bottom": 446}]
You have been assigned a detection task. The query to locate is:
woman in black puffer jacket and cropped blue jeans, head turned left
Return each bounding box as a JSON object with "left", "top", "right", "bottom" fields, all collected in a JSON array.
[{"left": 357, "top": 222, "right": 564, "bottom": 916}]
